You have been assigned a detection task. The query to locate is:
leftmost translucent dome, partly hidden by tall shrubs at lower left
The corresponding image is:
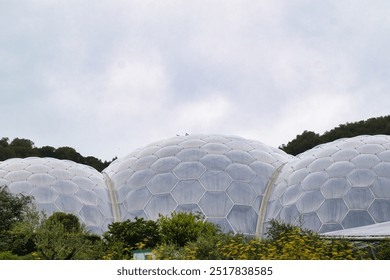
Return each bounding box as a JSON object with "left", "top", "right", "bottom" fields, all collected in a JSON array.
[{"left": 0, "top": 157, "right": 113, "bottom": 234}]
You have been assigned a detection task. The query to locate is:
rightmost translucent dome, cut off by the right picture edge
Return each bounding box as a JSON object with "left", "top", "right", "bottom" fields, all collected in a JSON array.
[{"left": 265, "top": 135, "right": 390, "bottom": 235}]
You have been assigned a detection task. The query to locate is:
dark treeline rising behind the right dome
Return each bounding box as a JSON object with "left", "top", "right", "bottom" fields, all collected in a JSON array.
[{"left": 279, "top": 116, "right": 390, "bottom": 155}]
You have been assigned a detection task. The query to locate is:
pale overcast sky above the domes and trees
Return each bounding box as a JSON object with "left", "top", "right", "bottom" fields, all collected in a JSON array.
[{"left": 0, "top": 0, "right": 390, "bottom": 160}]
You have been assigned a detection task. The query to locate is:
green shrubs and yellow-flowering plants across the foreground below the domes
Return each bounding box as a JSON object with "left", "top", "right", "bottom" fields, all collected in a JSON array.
[{"left": 0, "top": 187, "right": 390, "bottom": 260}]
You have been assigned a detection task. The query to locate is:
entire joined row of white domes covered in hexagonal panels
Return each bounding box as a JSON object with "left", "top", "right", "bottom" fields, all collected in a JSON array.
[{"left": 4, "top": 135, "right": 390, "bottom": 238}]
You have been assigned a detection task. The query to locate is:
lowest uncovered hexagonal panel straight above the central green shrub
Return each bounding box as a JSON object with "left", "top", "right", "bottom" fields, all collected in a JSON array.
[{"left": 172, "top": 180, "right": 205, "bottom": 204}]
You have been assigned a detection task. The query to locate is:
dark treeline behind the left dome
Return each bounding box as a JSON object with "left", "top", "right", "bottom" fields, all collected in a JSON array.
[{"left": 0, "top": 137, "right": 111, "bottom": 171}]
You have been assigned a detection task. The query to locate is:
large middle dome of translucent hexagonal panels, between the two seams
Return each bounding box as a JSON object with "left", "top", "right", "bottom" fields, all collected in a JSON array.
[{"left": 104, "top": 135, "right": 290, "bottom": 235}]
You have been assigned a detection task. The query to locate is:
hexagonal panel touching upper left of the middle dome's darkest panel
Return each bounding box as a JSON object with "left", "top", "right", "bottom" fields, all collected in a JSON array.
[{"left": 199, "top": 192, "right": 233, "bottom": 217}]
